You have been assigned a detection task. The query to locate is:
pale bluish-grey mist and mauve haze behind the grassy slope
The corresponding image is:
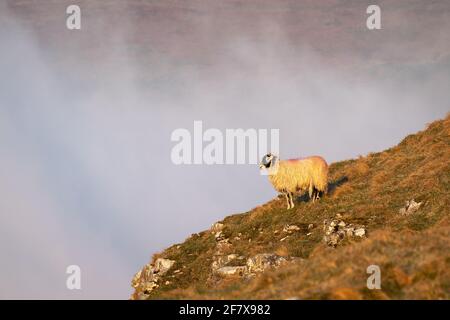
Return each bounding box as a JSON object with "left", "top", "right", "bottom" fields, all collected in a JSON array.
[{"left": 0, "top": 1, "right": 450, "bottom": 298}]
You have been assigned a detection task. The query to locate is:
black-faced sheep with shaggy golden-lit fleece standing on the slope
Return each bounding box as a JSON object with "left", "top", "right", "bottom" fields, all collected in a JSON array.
[{"left": 259, "top": 153, "right": 328, "bottom": 209}]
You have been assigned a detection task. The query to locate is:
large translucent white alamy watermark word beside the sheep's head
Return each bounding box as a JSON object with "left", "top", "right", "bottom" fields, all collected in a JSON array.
[{"left": 170, "top": 121, "right": 280, "bottom": 165}]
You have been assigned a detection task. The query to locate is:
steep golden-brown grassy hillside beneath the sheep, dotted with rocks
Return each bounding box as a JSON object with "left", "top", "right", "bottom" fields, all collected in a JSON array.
[{"left": 133, "top": 116, "right": 450, "bottom": 299}]
